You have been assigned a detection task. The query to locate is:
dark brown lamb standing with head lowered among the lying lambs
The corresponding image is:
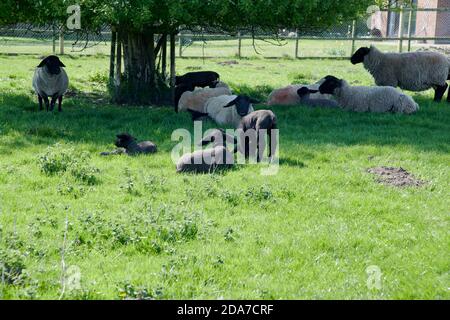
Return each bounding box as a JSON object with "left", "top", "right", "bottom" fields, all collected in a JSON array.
[{"left": 238, "top": 110, "right": 277, "bottom": 162}]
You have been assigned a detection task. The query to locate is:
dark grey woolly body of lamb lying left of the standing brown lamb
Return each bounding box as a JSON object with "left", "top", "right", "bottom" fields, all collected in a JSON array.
[{"left": 176, "top": 146, "right": 234, "bottom": 173}]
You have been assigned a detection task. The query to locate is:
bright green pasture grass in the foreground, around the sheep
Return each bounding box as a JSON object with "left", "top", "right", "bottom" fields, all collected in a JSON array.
[{"left": 0, "top": 56, "right": 450, "bottom": 299}]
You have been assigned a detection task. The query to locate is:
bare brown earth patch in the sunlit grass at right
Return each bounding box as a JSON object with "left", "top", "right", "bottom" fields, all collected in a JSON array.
[{"left": 367, "top": 167, "right": 425, "bottom": 187}]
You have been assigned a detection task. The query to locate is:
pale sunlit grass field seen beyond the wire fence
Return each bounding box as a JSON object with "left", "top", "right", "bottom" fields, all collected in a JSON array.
[{"left": 0, "top": 37, "right": 436, "bottom": 58}]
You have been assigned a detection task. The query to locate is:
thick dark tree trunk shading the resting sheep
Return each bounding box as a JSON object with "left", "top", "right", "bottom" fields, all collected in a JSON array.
[{"left": 114, "top": 31, "right": 170, "bottom": 105}]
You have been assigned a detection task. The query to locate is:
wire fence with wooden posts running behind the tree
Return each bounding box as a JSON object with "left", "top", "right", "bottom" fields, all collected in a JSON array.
[{"left": 0, "top": 6, "right": 450, "bottom": 59}]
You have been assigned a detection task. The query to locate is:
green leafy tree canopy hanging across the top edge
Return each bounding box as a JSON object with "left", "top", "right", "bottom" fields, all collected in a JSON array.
[{"left": 0, "top": 0, "right": 374, "bottom": 33}]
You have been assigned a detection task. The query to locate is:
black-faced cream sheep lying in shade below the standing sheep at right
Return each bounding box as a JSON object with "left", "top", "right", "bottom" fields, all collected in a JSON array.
[{"left": 319, "top": 76, "right": 419, "bottom": 114}]
